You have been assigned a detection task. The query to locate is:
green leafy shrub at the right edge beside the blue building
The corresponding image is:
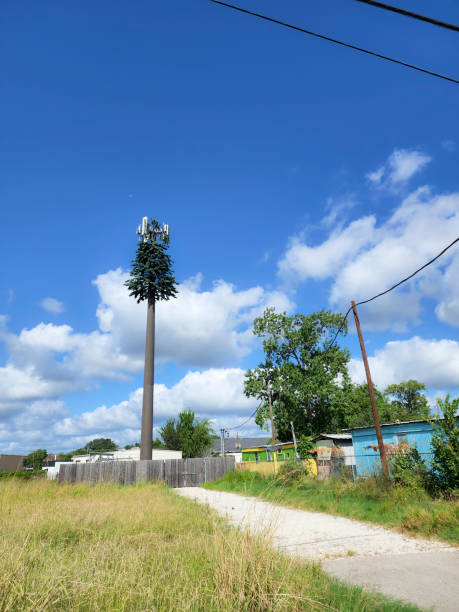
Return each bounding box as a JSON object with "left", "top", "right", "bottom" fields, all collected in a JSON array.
[{"left": 430, "top": 394, "right": 459, "bottom": 491}]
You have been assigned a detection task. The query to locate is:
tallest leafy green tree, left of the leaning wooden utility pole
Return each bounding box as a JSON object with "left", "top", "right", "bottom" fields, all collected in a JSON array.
[{"left": 248, "top": 308, "right": 349, "bottom": 440}]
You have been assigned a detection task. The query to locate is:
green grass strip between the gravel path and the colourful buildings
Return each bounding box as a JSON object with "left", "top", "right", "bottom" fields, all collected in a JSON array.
[{"left": 206, "top": 472, "right": 459, "bottom": 544}]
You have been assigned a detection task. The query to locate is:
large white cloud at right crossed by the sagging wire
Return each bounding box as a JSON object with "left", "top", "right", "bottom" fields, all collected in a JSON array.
[{"left": 278, "top": 187, "right": 459, "bottom": 331}]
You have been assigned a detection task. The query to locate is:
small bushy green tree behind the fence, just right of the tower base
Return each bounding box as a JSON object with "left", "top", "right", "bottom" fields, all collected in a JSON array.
[{"left": 159, "top": 410, "right": 214, "bottom": 459}]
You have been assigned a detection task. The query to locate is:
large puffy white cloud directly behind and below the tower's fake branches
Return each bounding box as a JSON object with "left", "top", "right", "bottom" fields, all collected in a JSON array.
[{"left": 94, "top": 269, "right": 293, "bottom": 367}]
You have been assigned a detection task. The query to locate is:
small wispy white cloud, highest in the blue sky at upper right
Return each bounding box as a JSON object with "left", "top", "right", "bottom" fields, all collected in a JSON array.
[{"left": 367, "top": 149, "right": 432, "bottom": 191}]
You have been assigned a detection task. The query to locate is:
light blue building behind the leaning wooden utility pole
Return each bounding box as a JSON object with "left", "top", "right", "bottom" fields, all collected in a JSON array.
[{"left": 349, "top": 417, "right": 459, "bottom": 476}]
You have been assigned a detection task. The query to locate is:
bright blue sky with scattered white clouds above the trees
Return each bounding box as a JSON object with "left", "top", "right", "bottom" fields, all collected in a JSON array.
[{"left": 0, "top": 0, "right": 459, "bottom": 452}]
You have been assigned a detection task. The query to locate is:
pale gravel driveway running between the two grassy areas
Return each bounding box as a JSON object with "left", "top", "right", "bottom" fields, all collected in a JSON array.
[{"left": 176, "top": 487, "right": 459, "bottom": 612}]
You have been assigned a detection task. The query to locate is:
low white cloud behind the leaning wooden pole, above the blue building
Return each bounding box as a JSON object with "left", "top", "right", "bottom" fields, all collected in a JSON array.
[{"left": 349, "top": 336, "right": 459, "bottom": 389}]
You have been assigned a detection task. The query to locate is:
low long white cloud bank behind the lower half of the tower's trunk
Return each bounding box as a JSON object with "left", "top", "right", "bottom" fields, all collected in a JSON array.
[{"left": 0, "top": 368, "right": 257, "bottom": 452}]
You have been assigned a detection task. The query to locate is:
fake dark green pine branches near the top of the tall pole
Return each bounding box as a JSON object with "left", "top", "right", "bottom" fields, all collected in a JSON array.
[{"left": 125, "top": 219, "right": 177, "bottom": 303}]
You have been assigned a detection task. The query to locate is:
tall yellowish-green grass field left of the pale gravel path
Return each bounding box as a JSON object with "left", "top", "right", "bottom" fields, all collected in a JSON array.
[{"left": 0, "top": 480, "right": 424, "bottom": 612}]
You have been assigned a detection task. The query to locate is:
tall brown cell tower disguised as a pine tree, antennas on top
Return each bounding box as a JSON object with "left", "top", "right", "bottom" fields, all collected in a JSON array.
[{"left": 125, "top": 217, "right": 177, "bottom": 459}]
